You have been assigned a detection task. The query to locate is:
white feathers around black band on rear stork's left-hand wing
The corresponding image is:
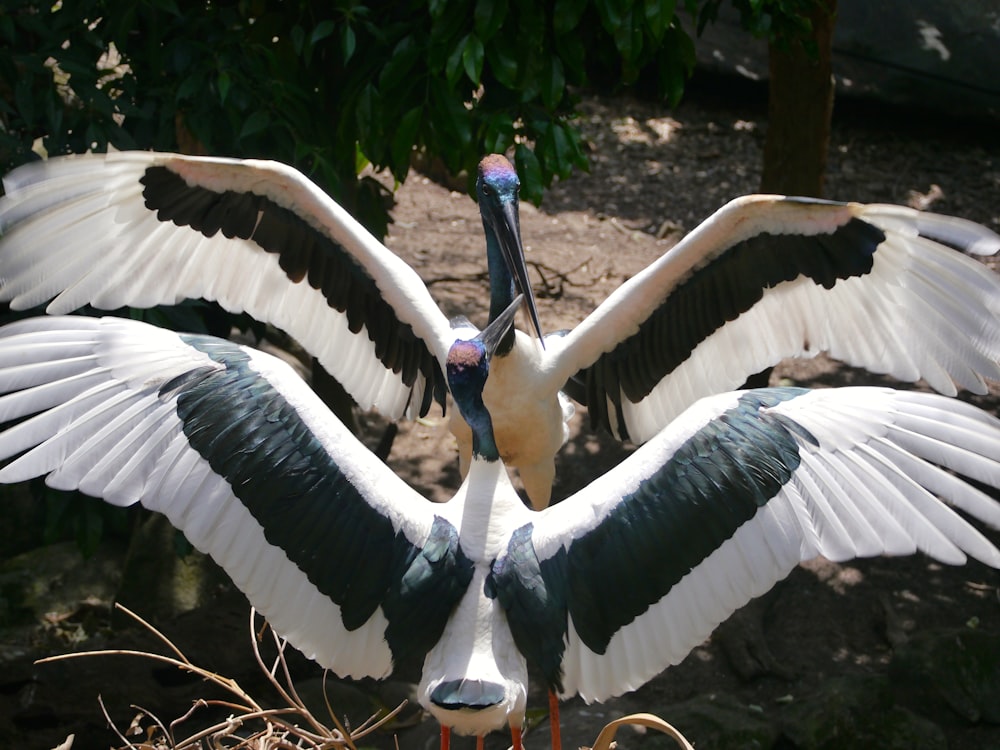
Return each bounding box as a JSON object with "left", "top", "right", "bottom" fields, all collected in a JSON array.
[{"left": 0, "top": 152, "right": 453, "bottom": 418}]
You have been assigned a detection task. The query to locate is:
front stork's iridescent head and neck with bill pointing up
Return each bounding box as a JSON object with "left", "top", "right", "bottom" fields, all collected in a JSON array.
[{"left": 445, "top": 295, "right": 524, "bottom": 461}]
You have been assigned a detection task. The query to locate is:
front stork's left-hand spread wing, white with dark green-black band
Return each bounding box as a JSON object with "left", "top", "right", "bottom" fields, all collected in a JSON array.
[{"left": 0, "top": 316, "right": 472, "bottom": 677}]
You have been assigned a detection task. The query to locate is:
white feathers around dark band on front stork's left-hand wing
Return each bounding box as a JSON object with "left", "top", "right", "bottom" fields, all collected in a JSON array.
[{"left": 0, "top": 316, "right": 433, "bottom": 677}]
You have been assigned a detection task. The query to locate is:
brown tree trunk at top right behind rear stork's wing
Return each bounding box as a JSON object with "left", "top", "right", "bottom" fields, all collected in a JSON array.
[{"left": 760, "top": 0, "right": 837, "bottom": 198}]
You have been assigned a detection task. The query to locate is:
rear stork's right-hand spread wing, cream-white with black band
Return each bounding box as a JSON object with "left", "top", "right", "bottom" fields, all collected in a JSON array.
[{"left": 546, "top": 195, "right": 1000, "bottom": 443}]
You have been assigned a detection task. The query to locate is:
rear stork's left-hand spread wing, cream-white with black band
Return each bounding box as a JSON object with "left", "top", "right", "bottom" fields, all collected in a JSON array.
[{"left": 0, "top": 152, "right": 452, "bottom": 418}]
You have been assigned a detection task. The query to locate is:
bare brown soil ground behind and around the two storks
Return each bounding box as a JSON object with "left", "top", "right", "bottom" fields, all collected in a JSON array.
[{"left": 0, "top": 82, "right": 1000, "bottom": 749}]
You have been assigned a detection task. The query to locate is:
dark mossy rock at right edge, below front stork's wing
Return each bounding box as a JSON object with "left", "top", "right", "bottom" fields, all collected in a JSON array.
[{"left": 889, "top": 628, "right": 1000, "bottom": 724}]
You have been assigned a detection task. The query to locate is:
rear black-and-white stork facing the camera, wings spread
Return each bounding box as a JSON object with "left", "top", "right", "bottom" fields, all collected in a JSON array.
[{"left": 0, "top": 152, "right": 1000, "bottom": 508}]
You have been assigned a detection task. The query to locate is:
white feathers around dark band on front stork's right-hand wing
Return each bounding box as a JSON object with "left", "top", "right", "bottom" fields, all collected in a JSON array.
[{"left": 532, "top": 388, "right": 1000, "bottom": 701}]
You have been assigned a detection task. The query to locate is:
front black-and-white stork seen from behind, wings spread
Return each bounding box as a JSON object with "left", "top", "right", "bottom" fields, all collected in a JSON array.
[{"left": 0, "top": 302, "right": 1000, "bottom": 747}]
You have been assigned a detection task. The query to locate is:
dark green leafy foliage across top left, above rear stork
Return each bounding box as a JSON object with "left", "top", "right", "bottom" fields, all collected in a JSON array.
[{"left": 0, "top": 0, "right": 697, "bottom": 220}]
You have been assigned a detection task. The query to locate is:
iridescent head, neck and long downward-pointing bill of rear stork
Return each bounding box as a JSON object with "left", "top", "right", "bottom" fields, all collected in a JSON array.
[{"left": 476, "top": 154, "right": 542, "bottom": 354}]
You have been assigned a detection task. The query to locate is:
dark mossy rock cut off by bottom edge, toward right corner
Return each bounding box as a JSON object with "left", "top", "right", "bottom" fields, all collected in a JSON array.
[{"left": 782, "top": 676, "right": 948, "bottom": 750}]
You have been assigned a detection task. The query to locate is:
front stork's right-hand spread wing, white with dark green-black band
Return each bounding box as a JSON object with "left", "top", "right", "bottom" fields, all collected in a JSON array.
[{"left": 492, "top": 388, "right": 1000, "bottom": 700}]
